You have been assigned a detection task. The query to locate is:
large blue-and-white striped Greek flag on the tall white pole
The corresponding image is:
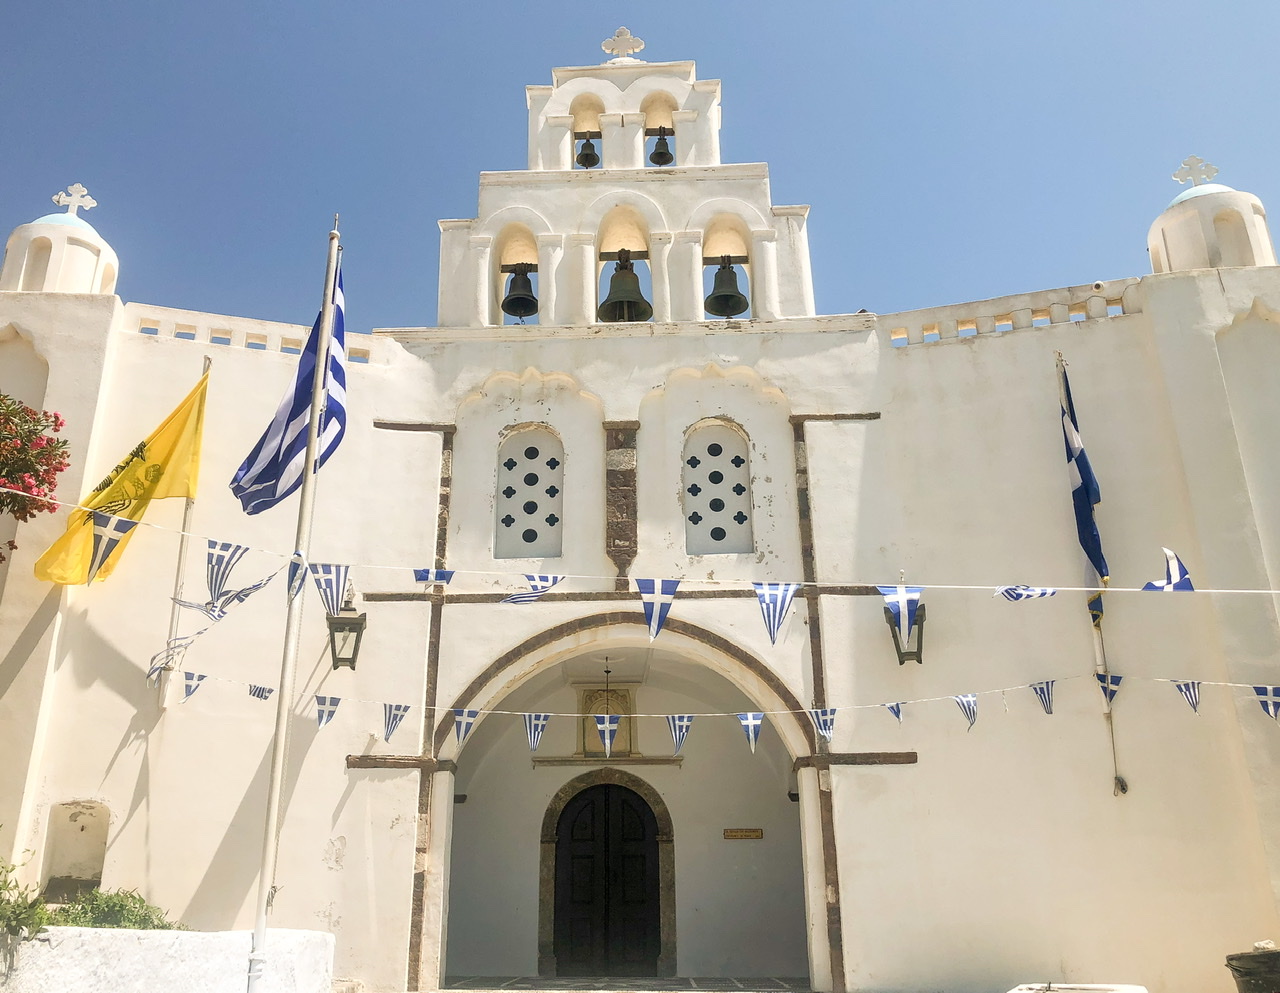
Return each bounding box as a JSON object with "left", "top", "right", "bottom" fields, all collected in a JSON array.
[{"left": 230, "top": 269, "right": 347, "bottom": 514}]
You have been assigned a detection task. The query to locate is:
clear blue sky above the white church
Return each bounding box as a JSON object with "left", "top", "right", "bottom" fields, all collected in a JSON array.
[{"left": 0, "top": 0, "right": 1280, "bottom": 330}]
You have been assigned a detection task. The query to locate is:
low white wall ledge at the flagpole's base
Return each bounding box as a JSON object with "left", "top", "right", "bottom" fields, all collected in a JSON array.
[{"left": 0, "top": 928, "right": 333, "bottom": 993}]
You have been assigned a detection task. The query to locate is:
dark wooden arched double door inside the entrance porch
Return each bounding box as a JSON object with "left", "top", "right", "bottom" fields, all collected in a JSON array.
[{"left": 556, "top": 784, "right": 659, "bottom": 976}]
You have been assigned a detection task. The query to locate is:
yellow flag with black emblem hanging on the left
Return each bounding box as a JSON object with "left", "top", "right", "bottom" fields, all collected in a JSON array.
[{"left": 36, "top": 372, "right": 209, "bottom": 586}]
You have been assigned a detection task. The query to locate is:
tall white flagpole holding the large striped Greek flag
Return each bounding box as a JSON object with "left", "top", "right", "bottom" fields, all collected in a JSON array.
[{"left": 248, "top": 214, "right": 339, "bottom": 993}]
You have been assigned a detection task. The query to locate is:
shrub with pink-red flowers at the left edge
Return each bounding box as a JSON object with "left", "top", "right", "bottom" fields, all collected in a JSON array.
[{"left": 0, "top": 393, "right": 67, "bottom": 562}]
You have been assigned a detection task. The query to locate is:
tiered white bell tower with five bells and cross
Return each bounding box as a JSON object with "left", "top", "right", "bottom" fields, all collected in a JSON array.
[{"left": 438, "top": 28, "right": 814, "bottom": 328}]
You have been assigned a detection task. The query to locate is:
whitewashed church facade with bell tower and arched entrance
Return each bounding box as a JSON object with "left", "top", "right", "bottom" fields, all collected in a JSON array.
[{"left": 0, "top": 32, "right": 1280, "bottom": 993}]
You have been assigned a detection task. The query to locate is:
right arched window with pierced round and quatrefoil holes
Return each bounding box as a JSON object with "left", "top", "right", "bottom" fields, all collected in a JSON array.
[{"left": 681, "top": 421, "right": 755, "bottom": 555}]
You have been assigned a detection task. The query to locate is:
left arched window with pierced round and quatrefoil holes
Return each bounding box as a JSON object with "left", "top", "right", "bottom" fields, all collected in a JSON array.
[{"left": 493, "top": 425, "right": 564, "bottom": 558}]
